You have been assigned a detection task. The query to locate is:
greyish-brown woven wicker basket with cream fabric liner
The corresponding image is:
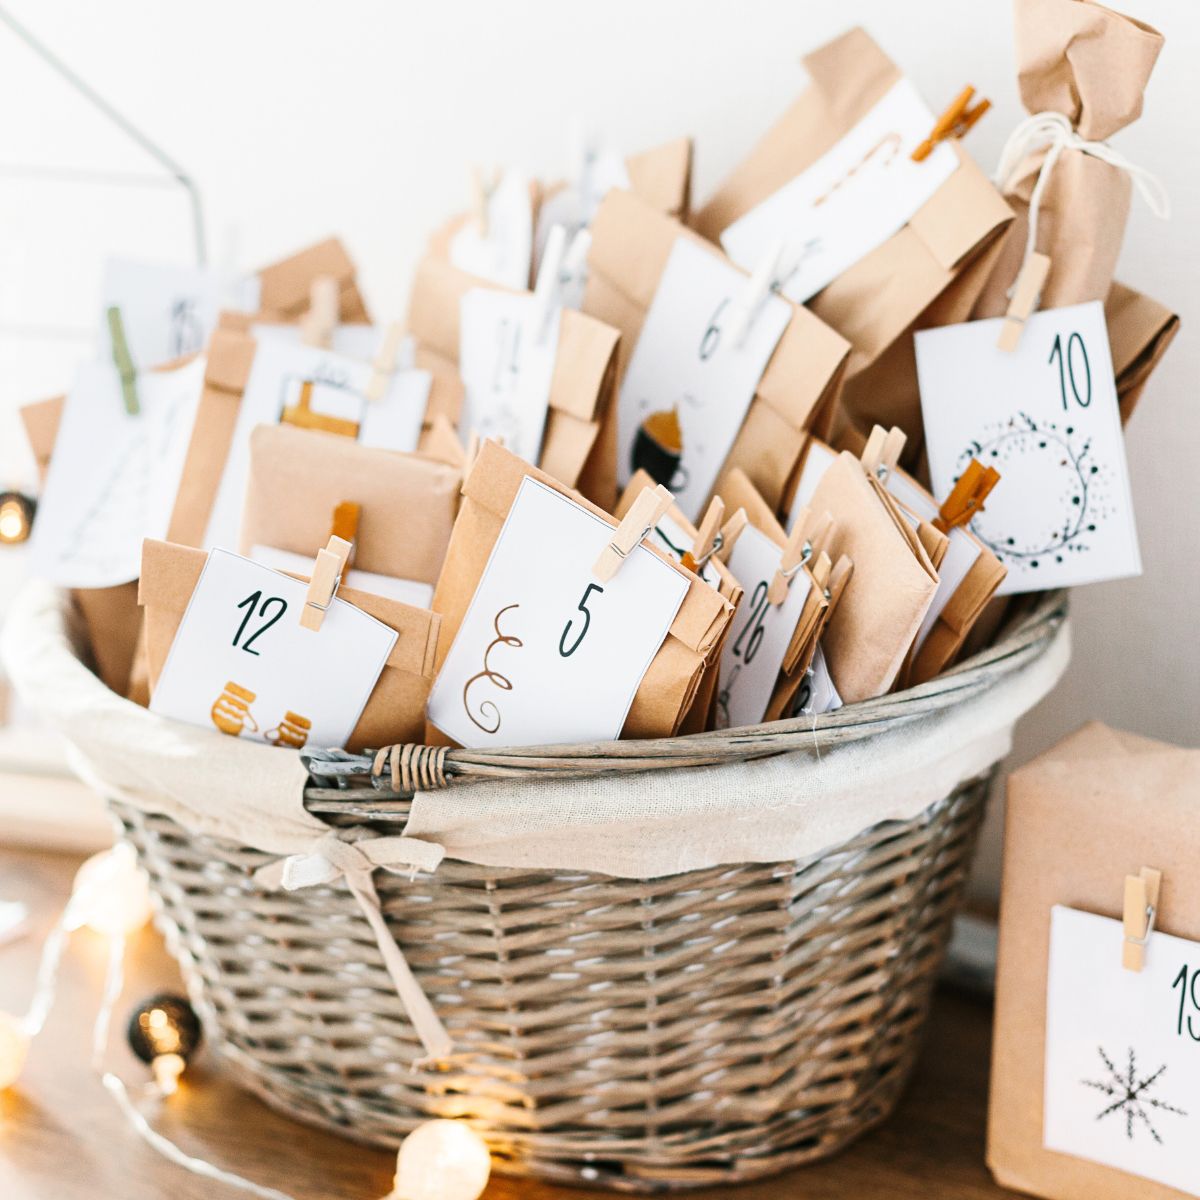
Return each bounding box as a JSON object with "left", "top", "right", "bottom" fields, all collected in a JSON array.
[{"left": 103, "top": 596, "right": 1066, "bottom": 1190}]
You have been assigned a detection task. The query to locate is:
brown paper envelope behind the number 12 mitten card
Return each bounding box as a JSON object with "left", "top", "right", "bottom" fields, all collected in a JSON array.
[{"left": 138, "top": 541, "right": 442, "bottom": 751}]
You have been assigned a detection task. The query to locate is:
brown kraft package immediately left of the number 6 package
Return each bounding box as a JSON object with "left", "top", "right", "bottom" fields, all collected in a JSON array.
[{"left": 408, "top": 254, "right": 618, "bottom": 499}]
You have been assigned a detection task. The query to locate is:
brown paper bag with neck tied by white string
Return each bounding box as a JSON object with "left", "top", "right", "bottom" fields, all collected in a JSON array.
[{"left": 976, "top": 0, "right": 1163, "bottom": 317}]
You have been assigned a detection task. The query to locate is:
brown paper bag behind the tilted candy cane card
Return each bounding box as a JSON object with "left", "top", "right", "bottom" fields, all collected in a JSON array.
[{"left": 694, "top": 29, "right": 1013, "bottom": 398}]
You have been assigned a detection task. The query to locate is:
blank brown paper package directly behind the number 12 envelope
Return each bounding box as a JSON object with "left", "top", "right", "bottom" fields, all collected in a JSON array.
[{"left": 239, "top": 425, "right": 462, "bottom": 583}]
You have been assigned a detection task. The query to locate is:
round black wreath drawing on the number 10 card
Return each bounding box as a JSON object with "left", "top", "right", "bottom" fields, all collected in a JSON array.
[{"left": 954, "top": 412, "right": 1115, "bottom": 569}]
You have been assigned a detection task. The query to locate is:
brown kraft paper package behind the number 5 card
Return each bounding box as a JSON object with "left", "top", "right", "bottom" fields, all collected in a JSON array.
[{"left": 426, "top": 440, "right": 733, "bottom": 744}]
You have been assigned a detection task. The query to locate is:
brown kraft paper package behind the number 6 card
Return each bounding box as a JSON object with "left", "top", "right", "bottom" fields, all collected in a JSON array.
[{"left": 581, "top": 191, "right": 850, "bottom": 508}]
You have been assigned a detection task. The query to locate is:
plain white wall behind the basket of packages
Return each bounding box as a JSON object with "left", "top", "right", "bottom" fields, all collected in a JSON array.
[{"left": 0, "top": 0, "right": 1200, "bottom": 878}]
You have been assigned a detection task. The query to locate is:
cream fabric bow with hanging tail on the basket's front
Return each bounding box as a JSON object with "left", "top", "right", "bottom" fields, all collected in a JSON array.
[{"left": 254, "top": 830, "right": 454, "bottom": 1060}]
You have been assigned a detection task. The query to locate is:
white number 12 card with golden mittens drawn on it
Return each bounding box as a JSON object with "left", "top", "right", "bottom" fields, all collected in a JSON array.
[{"left": 150, "top": 550, "right": 397, "bottom": 749}]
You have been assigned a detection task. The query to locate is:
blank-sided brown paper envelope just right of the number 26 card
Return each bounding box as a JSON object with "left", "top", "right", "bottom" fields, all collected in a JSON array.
[{"left": 810, "top": 451, "right": 937, "bottom": 704}]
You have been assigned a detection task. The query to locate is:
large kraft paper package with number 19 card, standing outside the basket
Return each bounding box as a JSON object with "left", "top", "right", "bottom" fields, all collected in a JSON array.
[{"left": 988, "top": 722, "right": 1200, "bottom": 1200}]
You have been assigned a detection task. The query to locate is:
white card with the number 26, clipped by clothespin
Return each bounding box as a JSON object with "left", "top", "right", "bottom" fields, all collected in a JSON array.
[{"left": 716, "top": 526, "right": 812, "bottom": 730}]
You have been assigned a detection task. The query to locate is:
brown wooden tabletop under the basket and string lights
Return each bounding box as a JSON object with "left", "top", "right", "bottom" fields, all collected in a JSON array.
[{"left": 0, "top": 848, "right": 1013, "bottom": 1200}]
